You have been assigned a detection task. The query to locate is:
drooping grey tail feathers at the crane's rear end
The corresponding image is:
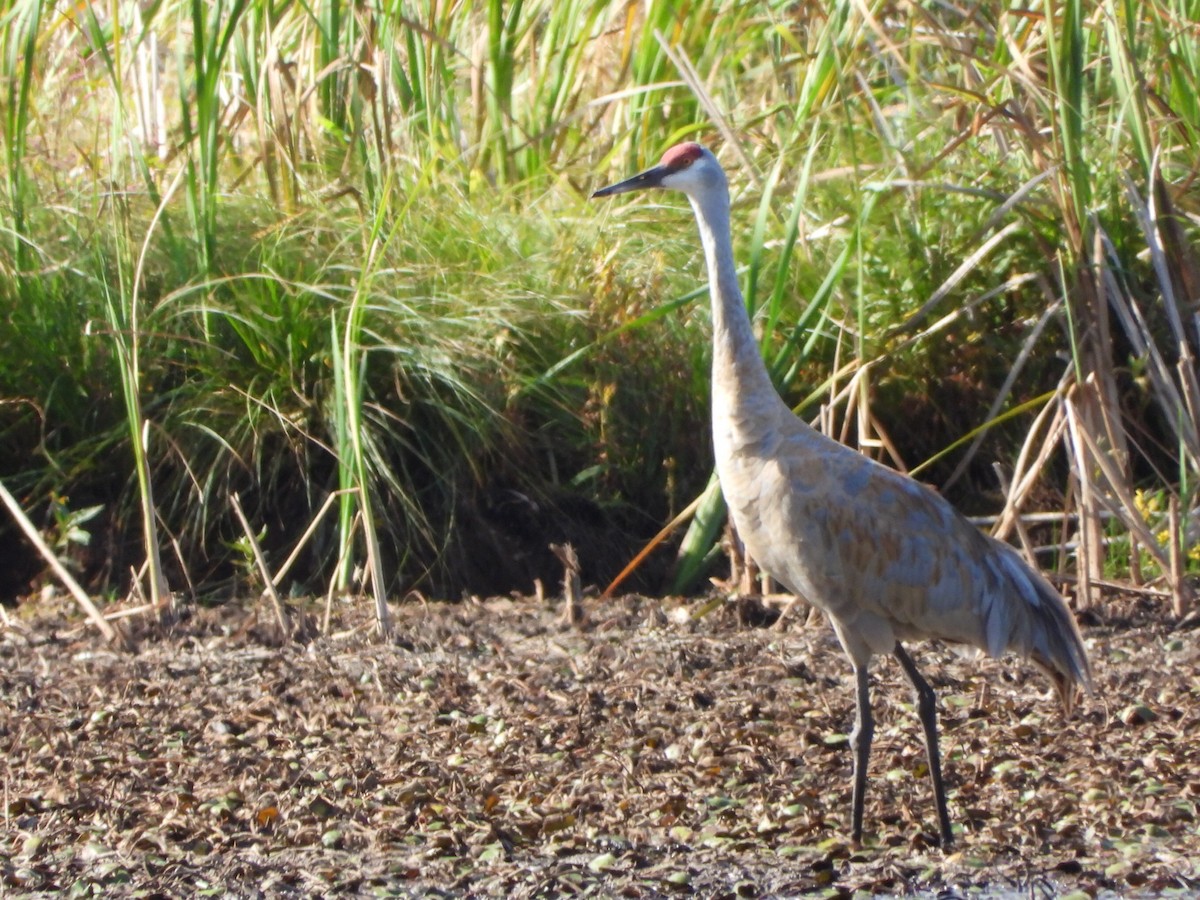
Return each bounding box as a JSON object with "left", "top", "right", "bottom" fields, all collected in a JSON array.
[{"left": 989, "top": 545, "right": 1092, "bottom": 715}]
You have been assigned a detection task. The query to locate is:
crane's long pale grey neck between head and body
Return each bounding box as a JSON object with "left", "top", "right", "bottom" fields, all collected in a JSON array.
[{"left": 690, "top": 187, "right": 791, "bottom": 448}]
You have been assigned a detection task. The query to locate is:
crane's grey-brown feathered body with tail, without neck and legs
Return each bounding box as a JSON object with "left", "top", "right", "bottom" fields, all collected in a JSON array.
[{"left": 721, "top": 426, "right": 1087, "bottom": 696}]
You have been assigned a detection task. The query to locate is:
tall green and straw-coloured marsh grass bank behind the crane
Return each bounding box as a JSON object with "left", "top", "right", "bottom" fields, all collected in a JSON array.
[{"left": 0, "top": 0, "right": 1200, "bottom": 625}]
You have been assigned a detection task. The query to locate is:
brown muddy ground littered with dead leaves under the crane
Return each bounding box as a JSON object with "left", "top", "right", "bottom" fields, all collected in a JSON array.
[{"left": 0, "top": 598, "right": 1200, "bottom": 898}]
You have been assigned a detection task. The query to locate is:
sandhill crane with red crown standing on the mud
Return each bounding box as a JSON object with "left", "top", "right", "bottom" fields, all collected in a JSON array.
[{"left": 593, "top": 143, "right": 1091, "bottom": 847}]
